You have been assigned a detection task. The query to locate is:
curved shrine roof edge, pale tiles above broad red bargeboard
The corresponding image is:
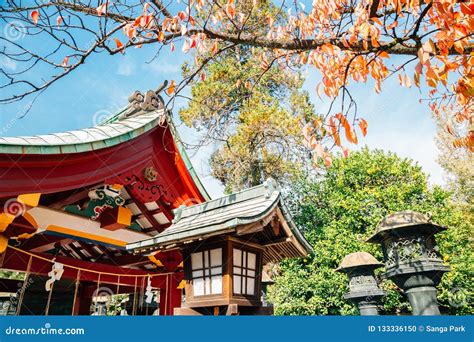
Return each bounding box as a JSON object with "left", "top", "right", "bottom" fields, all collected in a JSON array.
[{"left": 0, "top": 91, "right": 208, "bottom": 207}]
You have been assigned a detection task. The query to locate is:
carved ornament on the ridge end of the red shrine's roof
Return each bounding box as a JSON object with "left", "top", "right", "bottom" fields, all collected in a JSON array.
[{"left": 118, "top": 80, "right": 168, "bottom": 120}]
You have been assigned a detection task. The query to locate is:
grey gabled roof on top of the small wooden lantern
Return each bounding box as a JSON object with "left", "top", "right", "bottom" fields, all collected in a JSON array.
[{"left": 127, "top": 180, "right": 312, "bottom": 262}]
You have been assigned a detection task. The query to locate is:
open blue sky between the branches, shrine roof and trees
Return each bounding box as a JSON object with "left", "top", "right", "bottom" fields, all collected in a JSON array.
[{"left": 0, "top": 31, "right": 444, "bottom": 197}]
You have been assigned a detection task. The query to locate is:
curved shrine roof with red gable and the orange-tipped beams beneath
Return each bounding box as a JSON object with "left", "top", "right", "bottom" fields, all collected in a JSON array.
[{"left": 0, "top": 87, "right": 209, "bottom": 270}]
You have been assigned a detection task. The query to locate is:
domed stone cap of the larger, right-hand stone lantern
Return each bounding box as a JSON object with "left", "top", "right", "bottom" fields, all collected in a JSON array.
[{"left": 367, "top": 210, "right": 447, "bottom": 243}]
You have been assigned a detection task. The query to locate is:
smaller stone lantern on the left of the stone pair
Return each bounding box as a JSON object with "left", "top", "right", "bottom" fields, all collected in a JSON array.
[{"left": 336, "top": 252, "right": 385, "bottom": 316}]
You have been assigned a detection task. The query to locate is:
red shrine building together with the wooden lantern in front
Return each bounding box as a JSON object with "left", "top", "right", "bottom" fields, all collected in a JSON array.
[{"left": 0, "top": 89, "right": 311, "bottom": 315}]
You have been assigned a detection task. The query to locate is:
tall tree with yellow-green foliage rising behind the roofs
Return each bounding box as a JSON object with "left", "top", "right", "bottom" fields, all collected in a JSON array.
[{"left": 180, "top": 1, "right": 315, "bottom": 191}]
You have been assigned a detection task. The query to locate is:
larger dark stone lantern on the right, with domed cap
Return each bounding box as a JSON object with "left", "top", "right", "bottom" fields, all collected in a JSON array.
[{"left": 367, "top": 211, "right": 449, "bottom": 315}]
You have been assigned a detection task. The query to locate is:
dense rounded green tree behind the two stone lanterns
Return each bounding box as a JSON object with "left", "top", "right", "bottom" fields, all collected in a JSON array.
[{"left": 269, "top": 149, "right": 474, "bottom": 315}]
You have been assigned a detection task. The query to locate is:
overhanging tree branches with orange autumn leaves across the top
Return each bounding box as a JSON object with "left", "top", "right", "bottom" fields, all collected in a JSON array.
[{"left": 0, "top": 0, "right": 474, "bottom": 156}]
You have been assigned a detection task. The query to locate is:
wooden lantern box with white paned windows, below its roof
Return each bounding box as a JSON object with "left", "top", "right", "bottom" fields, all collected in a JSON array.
[{"left": 184, "top": 236, "right": 263, "bottom": 308}]
